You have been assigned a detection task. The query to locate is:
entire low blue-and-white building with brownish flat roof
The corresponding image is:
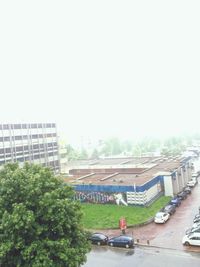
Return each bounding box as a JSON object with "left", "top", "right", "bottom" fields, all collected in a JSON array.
[{"left": 65, "top": 156, "right": 193, "bottom": 206}]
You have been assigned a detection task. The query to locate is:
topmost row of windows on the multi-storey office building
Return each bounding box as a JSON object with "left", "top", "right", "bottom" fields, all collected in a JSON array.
[{"left": 0, "top": 123, "right": 56, "bottom": 130}]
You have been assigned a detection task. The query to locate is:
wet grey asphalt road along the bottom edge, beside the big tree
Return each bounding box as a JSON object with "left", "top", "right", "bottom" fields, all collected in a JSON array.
[{"left": 83, "top": 246, "right": 200, "bottom": 267}]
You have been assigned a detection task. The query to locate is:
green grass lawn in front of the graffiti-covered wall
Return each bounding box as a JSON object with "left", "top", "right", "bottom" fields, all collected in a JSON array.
[{"left": 81, "top": 196, "right": 171, "bottom": 229}]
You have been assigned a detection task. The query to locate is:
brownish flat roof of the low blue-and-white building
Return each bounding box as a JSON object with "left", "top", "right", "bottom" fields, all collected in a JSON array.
[{"left": 64, "top": 157, "right": 189, "bottom": 186}]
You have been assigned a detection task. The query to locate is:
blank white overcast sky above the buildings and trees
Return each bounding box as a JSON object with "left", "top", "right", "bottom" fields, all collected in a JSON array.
[{"left": 0, "top": 0, "right": 200, "bottom": 146}]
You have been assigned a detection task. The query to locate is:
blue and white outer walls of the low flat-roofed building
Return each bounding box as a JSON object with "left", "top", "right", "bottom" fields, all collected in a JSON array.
[{"left": 69, "top": 157, "right": 195, "bottom": 205}]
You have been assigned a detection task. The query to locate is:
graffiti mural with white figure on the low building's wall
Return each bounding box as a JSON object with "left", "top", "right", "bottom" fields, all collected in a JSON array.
[{"left": 75, "top": 191, "right": 128, "bottom": 206}]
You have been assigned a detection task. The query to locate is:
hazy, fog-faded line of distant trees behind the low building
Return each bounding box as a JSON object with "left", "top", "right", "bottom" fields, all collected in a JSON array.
[{"left": 65, "top": 133, "right": 200, "bottom": 160}]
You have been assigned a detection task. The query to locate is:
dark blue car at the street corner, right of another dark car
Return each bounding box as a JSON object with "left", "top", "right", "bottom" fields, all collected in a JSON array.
[{"left": 108, "top": 235, "right": 134, "bottom": 248}]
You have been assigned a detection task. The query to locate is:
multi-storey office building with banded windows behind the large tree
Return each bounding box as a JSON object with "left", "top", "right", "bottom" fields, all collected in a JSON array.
[{"left": 0, "top": 123, "right": 60, "bottom": 172}]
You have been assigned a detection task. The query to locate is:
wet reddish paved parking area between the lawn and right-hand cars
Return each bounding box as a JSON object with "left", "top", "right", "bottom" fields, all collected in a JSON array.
[{"left": 102, "top": 183, "right": 200, "bottom": 252}]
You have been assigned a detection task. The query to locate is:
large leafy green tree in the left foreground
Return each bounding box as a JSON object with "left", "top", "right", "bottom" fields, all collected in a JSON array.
[{"left": 0, "top": 163, "right": 90, "bottom": 267}]
